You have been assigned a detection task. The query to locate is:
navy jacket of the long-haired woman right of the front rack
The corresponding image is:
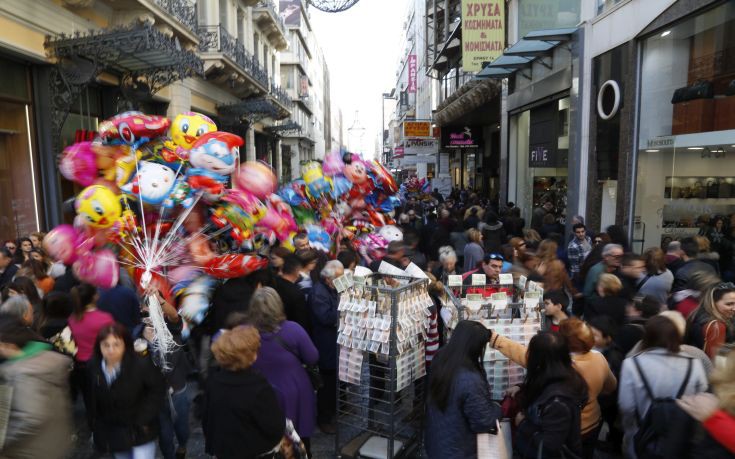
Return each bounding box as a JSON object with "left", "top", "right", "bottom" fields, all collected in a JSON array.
[{"left": 424, "top": 369, "right": 502, "bottom": 459}]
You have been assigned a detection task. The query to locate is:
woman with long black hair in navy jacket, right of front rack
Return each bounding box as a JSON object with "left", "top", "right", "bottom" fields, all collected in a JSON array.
[{"left": 425, "top": 320, "right": 502, "bottom": 459}]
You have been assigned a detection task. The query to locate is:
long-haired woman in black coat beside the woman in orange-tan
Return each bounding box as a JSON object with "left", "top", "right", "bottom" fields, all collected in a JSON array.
[{"left": 515, "top": 332, "right": 587, "bottom": 458}]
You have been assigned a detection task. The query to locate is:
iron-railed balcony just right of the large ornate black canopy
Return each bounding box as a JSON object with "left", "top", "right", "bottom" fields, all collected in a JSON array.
[{"left": 198, "top": 25, "right": 270, "bottom": 97}]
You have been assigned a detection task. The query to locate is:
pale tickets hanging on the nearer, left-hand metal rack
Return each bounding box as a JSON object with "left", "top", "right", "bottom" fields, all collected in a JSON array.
[{"left": 337, "top": 281, "right": 434, "bottom": 390}]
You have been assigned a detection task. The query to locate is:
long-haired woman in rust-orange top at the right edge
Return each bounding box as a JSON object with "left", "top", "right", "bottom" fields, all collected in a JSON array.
[{"left": 687, "top": 282, "right": 735, "bottom": 358}]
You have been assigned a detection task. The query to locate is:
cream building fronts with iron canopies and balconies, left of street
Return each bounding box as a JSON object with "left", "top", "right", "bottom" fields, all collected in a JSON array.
[{"left": 0, "top": 0, "right": 331, "bottom": 239}]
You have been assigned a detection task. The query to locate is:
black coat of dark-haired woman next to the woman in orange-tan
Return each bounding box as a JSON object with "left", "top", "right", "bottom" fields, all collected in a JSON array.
[{"left": 515, "top": 382, "right": 587, "bottom": 459}]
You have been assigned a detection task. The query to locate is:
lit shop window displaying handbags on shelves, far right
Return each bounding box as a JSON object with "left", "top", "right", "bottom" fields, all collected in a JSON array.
[{"left": 633, "top": 2, "right": 735, "bottom": 252}]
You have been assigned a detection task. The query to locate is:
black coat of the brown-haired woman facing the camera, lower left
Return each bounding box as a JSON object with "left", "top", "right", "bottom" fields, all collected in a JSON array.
[{"left": 88, "top": 349, "right": 166, "bottom": 452}]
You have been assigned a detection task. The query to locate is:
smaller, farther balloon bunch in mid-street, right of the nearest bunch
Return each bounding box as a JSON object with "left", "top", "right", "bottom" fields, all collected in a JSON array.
[{"left": 278, "top": 151, "right": 400, "bottom": 259}]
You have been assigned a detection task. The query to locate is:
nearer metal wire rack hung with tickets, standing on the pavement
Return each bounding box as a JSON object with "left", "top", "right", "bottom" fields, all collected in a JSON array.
[{"left": 335, "top": 274, "right": 433, "bottom": 459}]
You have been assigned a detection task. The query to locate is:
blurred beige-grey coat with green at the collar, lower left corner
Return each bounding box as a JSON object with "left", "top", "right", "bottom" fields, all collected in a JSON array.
[{"left": 0, "top": 342, "right": 74, "bottom": 459}]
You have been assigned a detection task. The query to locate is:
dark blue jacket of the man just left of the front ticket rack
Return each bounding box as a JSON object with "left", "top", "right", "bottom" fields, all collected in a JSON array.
[{"left": 309, "top": 281, "right": 339, "bottom": 370}]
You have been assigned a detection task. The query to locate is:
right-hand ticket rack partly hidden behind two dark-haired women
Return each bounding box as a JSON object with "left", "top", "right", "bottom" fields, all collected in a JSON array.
[{"left": 441, "top": 281, "right": 544, "bottom": 400}]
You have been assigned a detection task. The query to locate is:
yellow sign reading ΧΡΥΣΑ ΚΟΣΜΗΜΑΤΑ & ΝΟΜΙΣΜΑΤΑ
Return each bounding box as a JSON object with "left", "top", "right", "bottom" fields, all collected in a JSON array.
[{"left": 462, "top": 0, "right": 505, "bottom": 72}]
